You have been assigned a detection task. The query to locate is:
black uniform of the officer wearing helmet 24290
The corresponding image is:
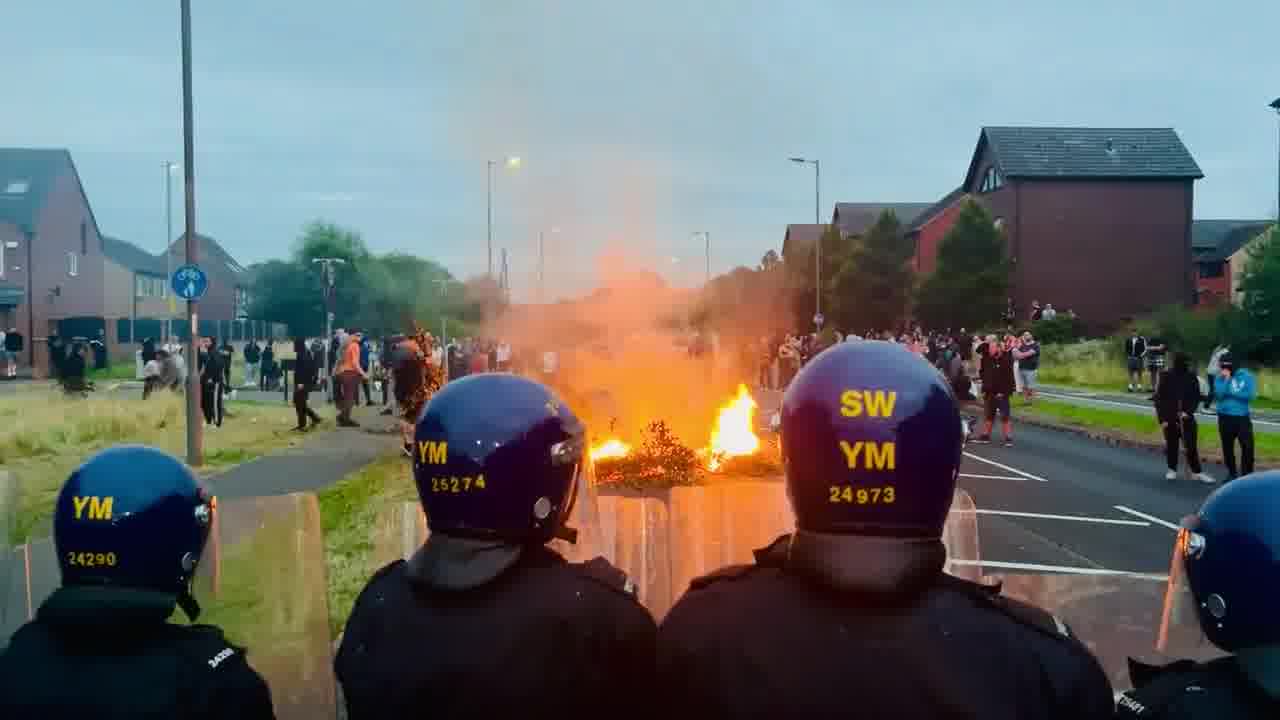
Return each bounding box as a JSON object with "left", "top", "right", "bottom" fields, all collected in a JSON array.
[{"left": 0, "top": 587, "right": 274, "bottom": 720}]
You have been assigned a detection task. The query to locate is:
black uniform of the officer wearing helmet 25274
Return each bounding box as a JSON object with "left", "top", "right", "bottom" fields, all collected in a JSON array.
[{"left": 334, "top": 547, "right": 655, "bottom": 720}]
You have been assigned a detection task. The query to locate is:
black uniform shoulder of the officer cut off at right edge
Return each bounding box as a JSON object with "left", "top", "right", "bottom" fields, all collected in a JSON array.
[{"left": 1115, "top": 656, "right": 1280, "bottom": 720}]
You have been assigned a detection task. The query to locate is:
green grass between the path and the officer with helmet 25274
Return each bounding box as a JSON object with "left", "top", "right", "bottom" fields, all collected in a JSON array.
[{"left": 319, "top": 455, "right": 417, "bottom": 637}]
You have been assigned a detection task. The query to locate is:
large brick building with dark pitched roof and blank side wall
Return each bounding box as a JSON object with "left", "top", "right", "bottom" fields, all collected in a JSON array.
[{"left": 963, "top": 127, "right": 1204, "bottom": 331}]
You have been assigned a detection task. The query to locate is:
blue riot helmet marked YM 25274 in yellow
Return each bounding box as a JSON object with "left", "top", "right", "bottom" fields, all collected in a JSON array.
[{"left": 412, "top": 373, "right": 589, "bottom": 585}]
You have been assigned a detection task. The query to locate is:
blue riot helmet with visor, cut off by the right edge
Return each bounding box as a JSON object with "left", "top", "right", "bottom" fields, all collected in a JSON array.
[{"left": 1161, "top": 470, "right": 1280, "bottom": 696}]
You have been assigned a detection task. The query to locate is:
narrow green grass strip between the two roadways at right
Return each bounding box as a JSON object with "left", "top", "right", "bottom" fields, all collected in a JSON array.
[{"left": 1014, "top": 400, "right": 1280, "bottom": 466}]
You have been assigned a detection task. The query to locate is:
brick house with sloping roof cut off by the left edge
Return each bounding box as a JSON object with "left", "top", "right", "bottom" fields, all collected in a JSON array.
[{"left": 0, "top": 147, "right": 104, "bottom": 377}]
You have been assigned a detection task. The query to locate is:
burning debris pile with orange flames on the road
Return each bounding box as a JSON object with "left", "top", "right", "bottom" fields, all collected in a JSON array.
[{"left": 590, "top": 384, "right": 781, "bottom": 488}]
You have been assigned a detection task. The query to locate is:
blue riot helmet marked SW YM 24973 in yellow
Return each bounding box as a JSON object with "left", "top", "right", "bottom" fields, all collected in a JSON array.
[{"left": 782, "top": 341, "right": 963, "bottom": 538}]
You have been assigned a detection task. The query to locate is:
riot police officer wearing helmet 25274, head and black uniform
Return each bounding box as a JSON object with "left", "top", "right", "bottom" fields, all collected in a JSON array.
[{"left": 334, "top": 374, "right": 655, "bottom": 720}]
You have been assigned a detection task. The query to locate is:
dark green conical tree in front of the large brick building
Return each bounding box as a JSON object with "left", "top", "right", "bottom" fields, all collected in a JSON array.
[{"left": 916, "top": 200, "right": 1012, "bottom": 328}]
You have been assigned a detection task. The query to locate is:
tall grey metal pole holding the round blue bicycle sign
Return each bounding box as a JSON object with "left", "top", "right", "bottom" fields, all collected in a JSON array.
[{"left": 182, "top": 0, "right": 205, "bottom": 466}]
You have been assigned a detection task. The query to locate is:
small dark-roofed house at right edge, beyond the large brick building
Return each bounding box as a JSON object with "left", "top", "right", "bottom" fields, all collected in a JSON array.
[{"left": 1192, "top": 220, "right": 1275, "bottom": 305}]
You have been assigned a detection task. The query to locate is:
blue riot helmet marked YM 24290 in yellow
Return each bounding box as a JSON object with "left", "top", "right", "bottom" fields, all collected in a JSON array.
[{"left": 54, "top": 445, "right": 215, "bottom": 620}]
